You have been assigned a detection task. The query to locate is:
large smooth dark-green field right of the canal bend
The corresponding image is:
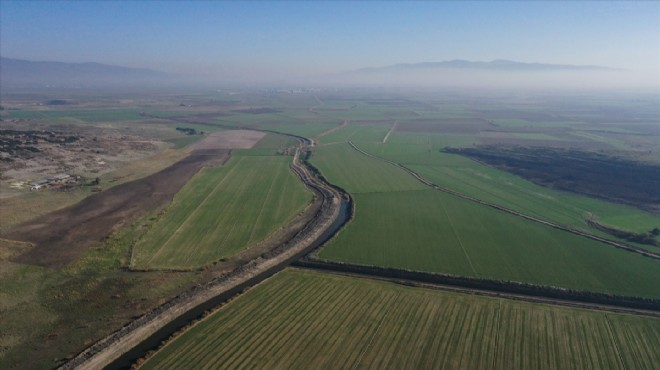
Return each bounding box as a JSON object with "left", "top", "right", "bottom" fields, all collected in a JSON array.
[{"left": 320, "top": 190, "right": 660, "bottom": 298}]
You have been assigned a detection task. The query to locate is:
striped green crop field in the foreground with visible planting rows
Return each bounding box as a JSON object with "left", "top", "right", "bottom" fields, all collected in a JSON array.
[{"left": 142, "top": 270, "right": 660, "bottom": 369}]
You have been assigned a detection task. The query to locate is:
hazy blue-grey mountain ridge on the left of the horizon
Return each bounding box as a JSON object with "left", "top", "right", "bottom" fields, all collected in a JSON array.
[{"left": 0, "top": 57, "right": 174, "bottom": 87}]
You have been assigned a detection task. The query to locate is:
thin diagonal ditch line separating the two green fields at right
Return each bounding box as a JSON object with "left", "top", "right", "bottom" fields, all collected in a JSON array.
[{"left": 348, "top": 141, "right": 660, "bottom": 260}]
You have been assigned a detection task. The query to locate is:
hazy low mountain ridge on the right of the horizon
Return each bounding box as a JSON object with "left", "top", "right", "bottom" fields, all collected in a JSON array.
[{"left": 353, "top": 59, "right": 614, "bottom": 73}]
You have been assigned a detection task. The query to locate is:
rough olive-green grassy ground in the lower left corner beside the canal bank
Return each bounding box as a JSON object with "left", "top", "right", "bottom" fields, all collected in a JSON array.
[{"left": 0, "top": 215, "right": 203, "bottom": 369}]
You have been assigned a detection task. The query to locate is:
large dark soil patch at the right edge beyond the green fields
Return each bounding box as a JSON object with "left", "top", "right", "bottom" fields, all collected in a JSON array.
[{"left": 445, "top": 147, "right": 660, "bottom": 214}]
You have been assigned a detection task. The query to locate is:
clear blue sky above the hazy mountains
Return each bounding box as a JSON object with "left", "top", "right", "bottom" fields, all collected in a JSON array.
[{"left": 0, "top": 0, "right": 660, "bottom": 83}]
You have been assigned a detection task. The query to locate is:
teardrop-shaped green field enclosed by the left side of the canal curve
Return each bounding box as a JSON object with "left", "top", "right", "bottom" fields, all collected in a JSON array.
[{"left": 132, "top": 156, "right": 312, "bottom": 268}]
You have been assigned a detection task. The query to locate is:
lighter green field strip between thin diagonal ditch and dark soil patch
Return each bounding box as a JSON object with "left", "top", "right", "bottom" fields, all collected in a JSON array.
[{"left": 359, "top": 139, "right": 660, "bottom": 234}]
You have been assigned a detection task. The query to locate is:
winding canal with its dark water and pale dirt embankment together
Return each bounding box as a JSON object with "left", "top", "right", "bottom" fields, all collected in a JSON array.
[{"left": 60, "top": 137, "right": 352, "bottom": 369}]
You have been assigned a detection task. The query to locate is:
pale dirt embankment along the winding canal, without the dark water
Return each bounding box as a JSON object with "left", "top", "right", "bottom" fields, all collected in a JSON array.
[{"left": 59, "top": 137, "right": 350, "bottom": 369}]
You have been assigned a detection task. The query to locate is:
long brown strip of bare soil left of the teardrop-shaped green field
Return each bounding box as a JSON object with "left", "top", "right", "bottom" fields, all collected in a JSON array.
[{"left": 2, "top": 150, "right": 229, "bottom": 268}]
